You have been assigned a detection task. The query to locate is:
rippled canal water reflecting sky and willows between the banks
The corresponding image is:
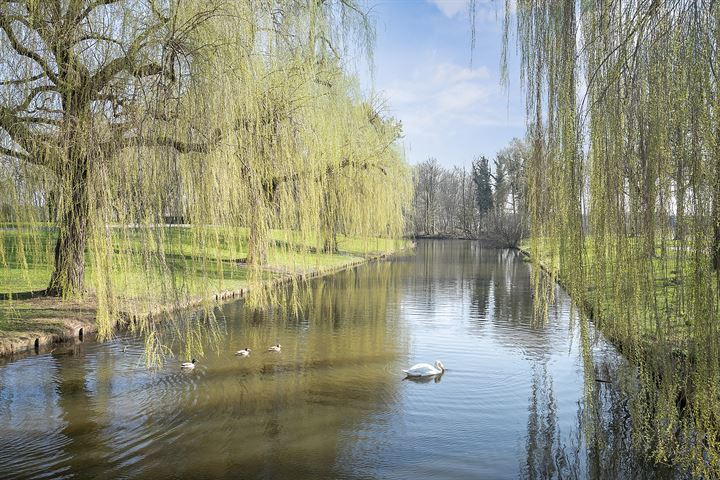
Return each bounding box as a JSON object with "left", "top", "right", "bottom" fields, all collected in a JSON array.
[{"left": 0, "top": 241, "right": 665, "bottom": 479}]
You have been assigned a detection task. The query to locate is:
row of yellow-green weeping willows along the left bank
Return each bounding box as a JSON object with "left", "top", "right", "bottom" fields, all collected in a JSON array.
[{"left": 0, "top": 0, "right": 412, "bottom": 354}]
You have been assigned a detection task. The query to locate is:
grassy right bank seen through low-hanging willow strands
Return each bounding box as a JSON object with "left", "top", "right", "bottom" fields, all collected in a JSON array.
[{"left": 521, "top": 238, "right": 720, "bottom": 478}]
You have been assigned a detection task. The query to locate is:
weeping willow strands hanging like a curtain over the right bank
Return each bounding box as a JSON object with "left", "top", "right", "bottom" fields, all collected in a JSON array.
[{"left": 496, "top": 0, "right": 720, "bottom": 472}]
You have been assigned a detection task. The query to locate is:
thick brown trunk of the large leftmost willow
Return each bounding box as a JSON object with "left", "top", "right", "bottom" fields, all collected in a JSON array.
[{"left": 47, "top": 155, "right": 89, "bottom": 296}]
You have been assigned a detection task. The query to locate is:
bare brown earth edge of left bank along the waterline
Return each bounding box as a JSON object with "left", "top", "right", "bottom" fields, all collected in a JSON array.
[{"left": 0, "top": 241, "right": 416, "bottom": 361}]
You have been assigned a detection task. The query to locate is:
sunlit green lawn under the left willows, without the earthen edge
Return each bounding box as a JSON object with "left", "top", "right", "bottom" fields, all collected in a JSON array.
[{"left": 0, "top": 227, "right": 407, "bottom": 298}]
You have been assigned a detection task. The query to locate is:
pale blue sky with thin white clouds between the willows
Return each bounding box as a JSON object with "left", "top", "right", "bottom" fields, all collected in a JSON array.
[{"left": 364, "top": 0, "right": 525, "bottom": 166}]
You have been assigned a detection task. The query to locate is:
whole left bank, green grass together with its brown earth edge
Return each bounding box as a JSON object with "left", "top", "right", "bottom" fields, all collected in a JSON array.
[{"left": 0, "top": 226, "right": 411, "bottom": 355}]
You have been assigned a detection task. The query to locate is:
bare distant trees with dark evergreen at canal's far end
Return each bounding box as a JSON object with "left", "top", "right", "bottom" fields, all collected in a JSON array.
[{"left": 411, "top": 138, "right": 529, "bottom": 246}]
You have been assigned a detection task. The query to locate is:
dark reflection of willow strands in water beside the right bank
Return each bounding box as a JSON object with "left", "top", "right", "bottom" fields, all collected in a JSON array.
[{"left": 523, "top": 344, "right": 680, "bottom": 480}]
